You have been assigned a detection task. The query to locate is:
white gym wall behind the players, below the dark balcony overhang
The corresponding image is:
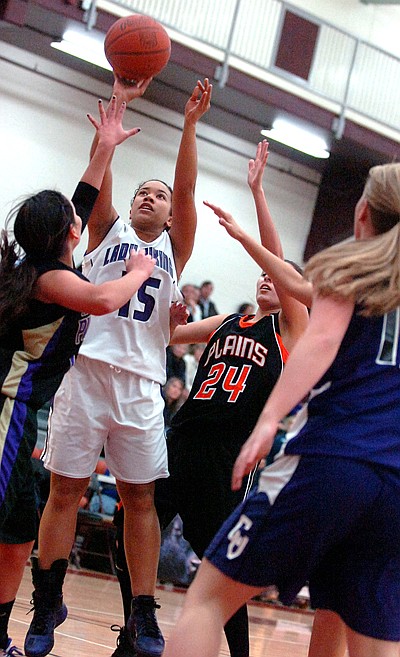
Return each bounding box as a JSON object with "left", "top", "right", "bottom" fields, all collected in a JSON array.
[{"left": 0, "top": 42, "right": 319, "bottom": 312}]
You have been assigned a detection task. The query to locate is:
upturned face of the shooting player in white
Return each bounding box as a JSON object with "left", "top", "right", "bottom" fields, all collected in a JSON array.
[{"left": 130, "top": 180, "right": 172, "bottom": 233}]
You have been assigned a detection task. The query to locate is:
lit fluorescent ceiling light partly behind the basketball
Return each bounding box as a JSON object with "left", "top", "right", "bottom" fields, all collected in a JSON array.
[{"left": 51, "top": 28, "right": 112, "bottom": 71}]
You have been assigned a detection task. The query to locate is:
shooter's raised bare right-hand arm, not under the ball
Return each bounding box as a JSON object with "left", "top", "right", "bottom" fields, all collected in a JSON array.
[{"left": 170, "top": 78, "right": 212, "bottom": 276}]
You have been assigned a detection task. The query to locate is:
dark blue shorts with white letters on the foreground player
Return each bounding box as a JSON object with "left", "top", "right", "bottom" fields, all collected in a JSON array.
[{"left": 205, "top": 455, "right": 400, "bottom": 641}]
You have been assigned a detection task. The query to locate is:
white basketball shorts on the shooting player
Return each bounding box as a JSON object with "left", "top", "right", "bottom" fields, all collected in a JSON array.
[{"left": 43, "top": 356, "right": 168, "bottom": 484}]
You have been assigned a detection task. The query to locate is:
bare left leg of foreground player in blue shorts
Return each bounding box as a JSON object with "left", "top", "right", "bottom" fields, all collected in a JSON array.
[{"left": 164, "top": 559, "right": 262, "bottom": 657}]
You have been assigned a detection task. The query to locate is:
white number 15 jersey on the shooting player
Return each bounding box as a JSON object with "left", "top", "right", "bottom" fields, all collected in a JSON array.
[{"left": 80, "top": 218, "right": 182, "bottom": 384}]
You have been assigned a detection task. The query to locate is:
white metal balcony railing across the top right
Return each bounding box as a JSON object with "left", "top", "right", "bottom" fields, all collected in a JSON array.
[{"left": 97, "top": 0, "right": 400, "bottom": 137}]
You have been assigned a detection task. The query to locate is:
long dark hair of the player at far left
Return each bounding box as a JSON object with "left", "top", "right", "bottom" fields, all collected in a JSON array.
[{"left": 0, "top": 189, "right": 74, "bottom": 333}]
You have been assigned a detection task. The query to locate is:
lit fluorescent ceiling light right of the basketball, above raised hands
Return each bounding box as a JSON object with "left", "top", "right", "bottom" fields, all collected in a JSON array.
[{"left": 261, "top": 119, "right": 330, "bottom": 158}]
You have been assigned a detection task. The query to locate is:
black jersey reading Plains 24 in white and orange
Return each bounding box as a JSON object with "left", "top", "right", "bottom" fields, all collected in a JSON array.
[{"left": 171, "top": 314, "right": 287, "bottom": 444}]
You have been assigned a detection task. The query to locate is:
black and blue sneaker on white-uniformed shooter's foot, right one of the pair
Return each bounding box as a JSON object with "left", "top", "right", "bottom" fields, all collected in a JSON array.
[{"left": 127, "top": 595, "right": 165, "bottom": 657}]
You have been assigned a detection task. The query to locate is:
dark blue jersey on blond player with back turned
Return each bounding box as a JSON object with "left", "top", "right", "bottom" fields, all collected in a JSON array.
[{"left": 285, "top": 308, "right": 400, "bottom": 468}]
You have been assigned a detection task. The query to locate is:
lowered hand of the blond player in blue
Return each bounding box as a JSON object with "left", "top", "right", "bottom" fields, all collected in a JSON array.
[{"left": 231, "top": 420, "right": 278, "bottom": 490}]
